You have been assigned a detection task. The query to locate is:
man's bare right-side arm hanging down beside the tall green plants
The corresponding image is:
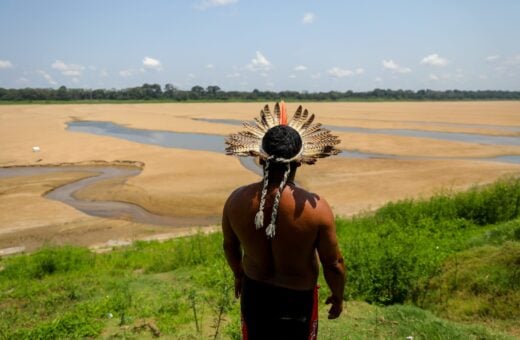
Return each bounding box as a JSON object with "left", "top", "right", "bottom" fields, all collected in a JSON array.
[{"left": 317, "top": 202, "right": 345, "bottom": 319}]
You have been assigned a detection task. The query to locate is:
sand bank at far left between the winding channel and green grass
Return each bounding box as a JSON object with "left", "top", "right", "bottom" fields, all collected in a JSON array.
[{"left": 0, "top": 172, "right": 177, "bottom": 250}]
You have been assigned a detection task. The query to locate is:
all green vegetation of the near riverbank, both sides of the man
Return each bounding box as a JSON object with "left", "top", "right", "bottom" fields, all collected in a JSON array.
[{"left": 0, "top": 178, "right": 520, "bottom": 339}]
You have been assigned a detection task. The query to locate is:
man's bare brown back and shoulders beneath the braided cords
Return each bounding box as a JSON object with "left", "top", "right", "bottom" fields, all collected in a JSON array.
[{"left": 223, "top": 183, "right": 337, "bottom": 290}]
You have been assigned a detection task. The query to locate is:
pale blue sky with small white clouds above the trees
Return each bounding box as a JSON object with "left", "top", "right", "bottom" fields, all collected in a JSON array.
[{"left": 0, "top": 0, "right": 520, "bottom": 92}]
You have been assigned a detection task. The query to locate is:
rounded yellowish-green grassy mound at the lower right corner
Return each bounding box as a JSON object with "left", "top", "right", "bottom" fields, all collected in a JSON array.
[{"left": 421, "top": 239, "right": 520, "bottom": 320}]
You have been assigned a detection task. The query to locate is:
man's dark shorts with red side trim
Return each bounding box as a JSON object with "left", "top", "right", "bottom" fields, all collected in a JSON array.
[{"left": 240, "top": 276, "right": 318, "bottom": 340}]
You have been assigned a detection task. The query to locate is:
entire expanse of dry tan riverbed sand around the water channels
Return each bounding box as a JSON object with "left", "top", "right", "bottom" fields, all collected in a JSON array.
[{"left": 0, "top": 101, "right": 520, "bottom": 249}]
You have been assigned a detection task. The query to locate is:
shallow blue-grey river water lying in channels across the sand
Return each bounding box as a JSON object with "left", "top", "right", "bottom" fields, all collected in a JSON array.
[{"left": 0, "top": 119, "right": 520, "bottom": 226}]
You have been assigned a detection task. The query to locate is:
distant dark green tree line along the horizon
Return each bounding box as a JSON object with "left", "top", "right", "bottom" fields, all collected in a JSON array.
[{"left": 0, "top": 84, "right": 520, "bottom": 102}]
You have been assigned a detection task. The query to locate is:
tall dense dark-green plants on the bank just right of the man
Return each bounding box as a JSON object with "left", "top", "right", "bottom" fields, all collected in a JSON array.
[{"left": 337, "top": 178, "right": 520, "bottom": 304}]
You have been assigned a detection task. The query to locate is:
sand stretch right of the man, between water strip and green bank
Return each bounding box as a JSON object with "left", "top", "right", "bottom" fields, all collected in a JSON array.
[{"left": 300, "top": 158, "right": 520, "bottom": 216}]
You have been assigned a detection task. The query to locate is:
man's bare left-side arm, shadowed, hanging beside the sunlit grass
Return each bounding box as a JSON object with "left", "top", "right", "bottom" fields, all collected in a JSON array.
[{"left": 222, "top": 202, "right": 244, "bottom": 298}]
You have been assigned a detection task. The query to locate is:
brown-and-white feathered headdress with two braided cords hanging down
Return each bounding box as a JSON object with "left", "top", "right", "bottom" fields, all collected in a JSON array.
[{"left": 226, "top": 102, "right": 341, "bottom": 237}]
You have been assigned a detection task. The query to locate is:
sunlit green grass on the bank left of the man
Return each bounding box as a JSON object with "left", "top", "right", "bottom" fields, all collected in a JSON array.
[{"left": 0, "top": 234, "right": 236, "bottom": 339}]
